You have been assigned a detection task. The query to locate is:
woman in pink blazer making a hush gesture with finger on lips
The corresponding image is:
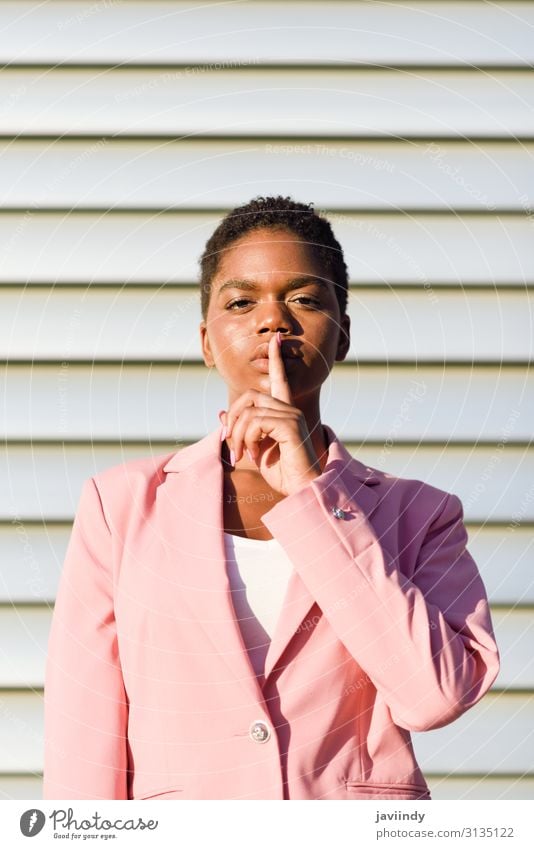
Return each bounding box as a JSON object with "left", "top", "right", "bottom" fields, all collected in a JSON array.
[{"left": 44, "top": 198, "right": 499, "bottom": 799}]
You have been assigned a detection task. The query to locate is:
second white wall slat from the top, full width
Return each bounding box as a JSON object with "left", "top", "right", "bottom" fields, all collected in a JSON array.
[{"left": 0, "top": 67, "right": 534, "bottom": 137}]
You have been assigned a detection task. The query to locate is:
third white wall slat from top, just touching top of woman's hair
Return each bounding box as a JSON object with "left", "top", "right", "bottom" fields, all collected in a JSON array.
[{"left": 0, "top": 139, "right": 534, "bottom": 210}]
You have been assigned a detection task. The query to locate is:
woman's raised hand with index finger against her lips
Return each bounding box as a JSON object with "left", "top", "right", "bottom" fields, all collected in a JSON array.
[{"left": 221, "top": 334, "right": 321, "bottom": 495}]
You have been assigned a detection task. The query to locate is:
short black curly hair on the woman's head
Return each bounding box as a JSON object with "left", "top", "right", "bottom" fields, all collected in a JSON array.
[{"left": 200, "top": 195, "right": 349, "bottom": 320}]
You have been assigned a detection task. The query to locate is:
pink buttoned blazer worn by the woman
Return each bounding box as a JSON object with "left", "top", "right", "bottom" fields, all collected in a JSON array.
[{"left": 44, "top": 427, "right": 499, "bottom": 799}]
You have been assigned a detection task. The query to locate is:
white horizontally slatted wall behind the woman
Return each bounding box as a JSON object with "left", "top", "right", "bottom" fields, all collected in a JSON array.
[{"left": 0, "top": 0, "right": 534, "bottom": 798}]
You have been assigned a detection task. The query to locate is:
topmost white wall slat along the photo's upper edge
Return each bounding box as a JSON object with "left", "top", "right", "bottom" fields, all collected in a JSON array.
[{"left": 0, "top": 0, "right": 534, "bottom": 65}]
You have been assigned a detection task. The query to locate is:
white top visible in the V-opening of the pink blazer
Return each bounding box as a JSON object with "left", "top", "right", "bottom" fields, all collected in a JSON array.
[{"left": 224, "top": 531, "right": 293, "bottom": 676}]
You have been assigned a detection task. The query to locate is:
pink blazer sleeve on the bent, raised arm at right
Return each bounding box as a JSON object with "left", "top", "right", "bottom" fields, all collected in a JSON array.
[{"left": 263, "top": 472, "right": 499, "bottom": 731}]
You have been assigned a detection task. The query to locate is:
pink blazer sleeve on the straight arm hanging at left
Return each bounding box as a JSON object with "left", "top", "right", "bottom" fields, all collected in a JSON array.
[{"left": 43, "top": 478, "right": 128, "bottom": 799}]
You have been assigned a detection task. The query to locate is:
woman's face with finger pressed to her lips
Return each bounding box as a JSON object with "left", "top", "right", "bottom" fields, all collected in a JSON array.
[{"left": 200, "top": 228, "right": 350, "bottom": 407}]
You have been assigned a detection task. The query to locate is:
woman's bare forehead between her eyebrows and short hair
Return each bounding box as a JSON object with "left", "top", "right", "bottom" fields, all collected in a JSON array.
[{"left": 215, "top": 228, "right": 321, "bottom": 282}]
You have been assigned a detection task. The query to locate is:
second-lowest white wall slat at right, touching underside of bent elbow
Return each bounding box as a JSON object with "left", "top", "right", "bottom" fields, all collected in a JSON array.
[{"left": 413, "top": 693, "right": 534, "bottom": 775}]
